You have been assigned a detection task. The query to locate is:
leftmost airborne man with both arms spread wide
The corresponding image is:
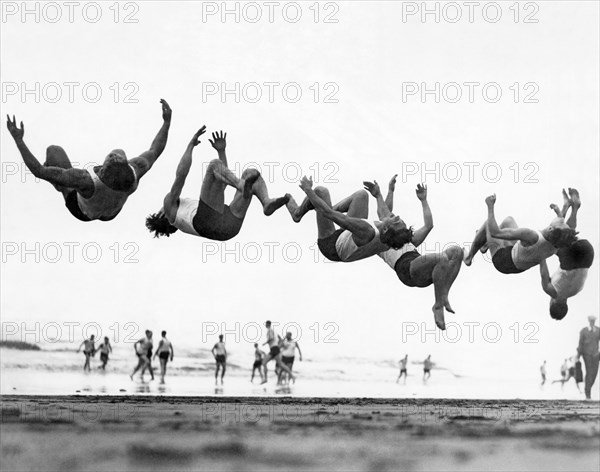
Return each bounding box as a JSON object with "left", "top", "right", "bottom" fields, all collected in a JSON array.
[{"left": 7, "top": 100, "right": 171, "bottom": 221}]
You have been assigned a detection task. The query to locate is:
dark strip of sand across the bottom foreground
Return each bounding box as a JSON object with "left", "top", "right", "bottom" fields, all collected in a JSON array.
[{"left": 0, "top": 395, "right": 600, "bottom": 471}]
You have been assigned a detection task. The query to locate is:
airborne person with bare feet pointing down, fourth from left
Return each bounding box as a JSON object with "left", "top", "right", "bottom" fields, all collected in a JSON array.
[{"left": 363, "top": 176, "right": 463, "bottom": 330}]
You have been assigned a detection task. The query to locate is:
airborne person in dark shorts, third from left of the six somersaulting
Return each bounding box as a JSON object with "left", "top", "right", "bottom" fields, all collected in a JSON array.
[{"left": 287, "top": 177, "right": 412, "bottom": 262}]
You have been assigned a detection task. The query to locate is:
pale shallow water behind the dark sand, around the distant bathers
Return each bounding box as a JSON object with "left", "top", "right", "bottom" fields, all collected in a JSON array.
[{"left": 0, "top": 344, "right": 598, "bottom": 400}]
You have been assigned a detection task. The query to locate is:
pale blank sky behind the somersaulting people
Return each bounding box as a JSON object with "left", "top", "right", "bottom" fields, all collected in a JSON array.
[{"left": 0, "top": 1, "right": 599, "bottom": 375}]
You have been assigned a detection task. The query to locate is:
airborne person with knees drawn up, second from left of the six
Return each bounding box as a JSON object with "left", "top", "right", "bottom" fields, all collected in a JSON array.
[{"left": 146, "top": 126, "right": 289, "bottom": 241}]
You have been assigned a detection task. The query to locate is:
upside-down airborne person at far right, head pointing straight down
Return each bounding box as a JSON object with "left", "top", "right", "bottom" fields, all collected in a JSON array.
[{"left": 540, "top": 188, "right": 594, "bottom": 320}]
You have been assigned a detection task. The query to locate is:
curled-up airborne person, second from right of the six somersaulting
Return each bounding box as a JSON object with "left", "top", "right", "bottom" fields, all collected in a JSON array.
[{"left": 465, "top": 195, "right": 577, "bottom": 274}]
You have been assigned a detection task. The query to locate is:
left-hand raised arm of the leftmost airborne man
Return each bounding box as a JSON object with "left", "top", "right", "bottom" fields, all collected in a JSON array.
[{"left": 6, "top": 115, "right": 94, "bottom": 193}]
